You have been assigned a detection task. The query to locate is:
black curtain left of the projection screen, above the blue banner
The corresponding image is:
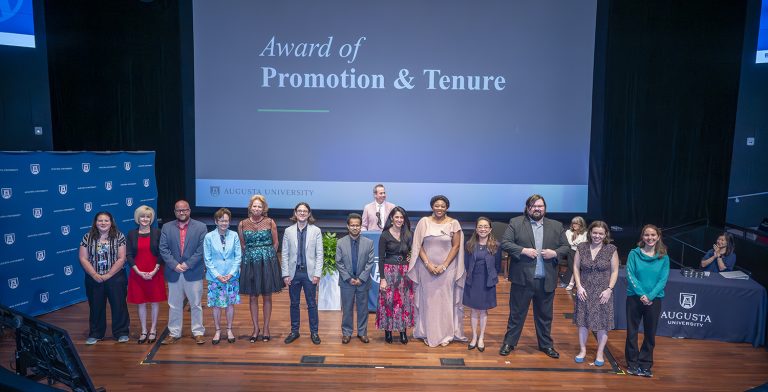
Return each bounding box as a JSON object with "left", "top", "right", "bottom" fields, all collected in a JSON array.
[{"left": 45, "top": 0, "right": 184, "bottom": 222}]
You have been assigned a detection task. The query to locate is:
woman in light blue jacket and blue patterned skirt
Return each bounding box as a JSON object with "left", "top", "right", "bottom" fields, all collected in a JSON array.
[{"left": 203, "top": 208, "right": 242, "bottom": 344}]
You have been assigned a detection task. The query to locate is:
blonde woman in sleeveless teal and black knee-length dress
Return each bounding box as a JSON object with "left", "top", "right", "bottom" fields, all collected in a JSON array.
[{"left": 237, "top": 195, "right": 284, "bottom": 343}]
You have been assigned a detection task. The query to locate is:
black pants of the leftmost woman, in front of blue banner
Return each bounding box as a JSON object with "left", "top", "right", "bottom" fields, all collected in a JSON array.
[{"left": 85, "top": 271, "right": 130, "bottom": 339}]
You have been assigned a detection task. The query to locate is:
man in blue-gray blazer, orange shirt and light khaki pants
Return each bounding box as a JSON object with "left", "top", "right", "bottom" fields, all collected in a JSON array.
[{"left": 160, "top": 200, "right": 208, "bottom": 344}]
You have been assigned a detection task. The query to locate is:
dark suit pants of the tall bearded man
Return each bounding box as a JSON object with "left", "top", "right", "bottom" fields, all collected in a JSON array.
[{"left": 504, "top": 279, "right": 555, "bottom": 348}]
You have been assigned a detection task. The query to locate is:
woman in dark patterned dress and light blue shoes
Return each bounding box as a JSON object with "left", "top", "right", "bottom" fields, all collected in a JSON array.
[{"left": 573, "top": 221, "right": 619, "bottom": 366}]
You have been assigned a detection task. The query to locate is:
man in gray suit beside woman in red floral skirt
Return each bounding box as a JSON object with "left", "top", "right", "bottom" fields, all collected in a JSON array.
[{"left": 336, "top": 213, "right": 373, "bottom": 344}]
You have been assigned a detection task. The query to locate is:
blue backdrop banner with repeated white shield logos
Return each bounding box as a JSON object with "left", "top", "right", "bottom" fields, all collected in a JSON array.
[{"left": 0, "top": 152, "right": 157, "bottom": 316}]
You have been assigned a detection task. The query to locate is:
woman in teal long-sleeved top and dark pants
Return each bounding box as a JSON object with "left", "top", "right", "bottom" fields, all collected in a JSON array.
[{"left": 624, "top": 225, "right": 669, "bottom": 377}]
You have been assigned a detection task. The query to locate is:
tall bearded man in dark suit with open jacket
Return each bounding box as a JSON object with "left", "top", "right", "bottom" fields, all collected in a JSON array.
[{"left": 499, "top": 195, "right": 569, "bottom": 358}]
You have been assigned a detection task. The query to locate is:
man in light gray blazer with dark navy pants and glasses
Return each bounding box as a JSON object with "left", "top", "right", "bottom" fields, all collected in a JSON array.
[{"left": 280, "top": 202, "right": 323, "bottom": 344}]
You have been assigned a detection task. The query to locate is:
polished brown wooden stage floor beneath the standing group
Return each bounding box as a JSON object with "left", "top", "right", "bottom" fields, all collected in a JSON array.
[{"left": 0, "top": 281, "right": 768, "bottom": 392}]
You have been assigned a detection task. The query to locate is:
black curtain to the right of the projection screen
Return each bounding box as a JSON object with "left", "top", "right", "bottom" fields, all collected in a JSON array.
[{"left": 591, "top": 1, "right": 746, "bottom": 226}]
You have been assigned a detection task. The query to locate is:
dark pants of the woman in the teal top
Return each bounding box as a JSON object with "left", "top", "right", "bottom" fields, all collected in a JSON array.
[{"left": 624, "top": 295, "right": 661, "bottom": 369}]
